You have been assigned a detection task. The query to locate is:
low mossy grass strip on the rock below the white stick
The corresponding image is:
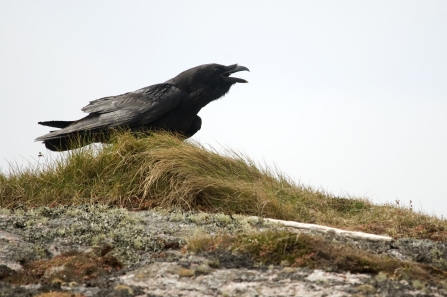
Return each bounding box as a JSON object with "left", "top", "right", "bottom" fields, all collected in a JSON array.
[{"left": 186, "top": 230, "right": 447, "bottom": 282}]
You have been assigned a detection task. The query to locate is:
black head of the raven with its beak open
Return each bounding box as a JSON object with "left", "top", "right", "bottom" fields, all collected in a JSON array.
[{"left": 168, "top": 64, "right": 250, "bottom": 102}]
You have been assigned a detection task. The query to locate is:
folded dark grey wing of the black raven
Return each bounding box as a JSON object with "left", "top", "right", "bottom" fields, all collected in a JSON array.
[{"left": 36, "top": 83, "right": 183, "bottom": 141}]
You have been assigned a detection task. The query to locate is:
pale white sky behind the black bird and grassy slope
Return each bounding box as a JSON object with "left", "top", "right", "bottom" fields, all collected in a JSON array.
[{"left": 0, "top": 0, "right": 447, "bottom": 216}]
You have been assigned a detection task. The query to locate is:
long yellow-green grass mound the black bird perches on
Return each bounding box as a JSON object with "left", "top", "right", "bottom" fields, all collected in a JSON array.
[{"left": 0, "top": 133, "right": 447, "bottom": 240}]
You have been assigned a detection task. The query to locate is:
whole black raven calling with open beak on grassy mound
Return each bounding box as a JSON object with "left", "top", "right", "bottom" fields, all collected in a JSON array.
[{"left": 36, "top": 64, "right": 249, "bottom": 151}]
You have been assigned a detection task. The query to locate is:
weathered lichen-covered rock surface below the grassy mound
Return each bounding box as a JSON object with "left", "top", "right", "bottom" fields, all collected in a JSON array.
[{"left": 0, "top": 205, "right": 447, "bottom": 297}]
